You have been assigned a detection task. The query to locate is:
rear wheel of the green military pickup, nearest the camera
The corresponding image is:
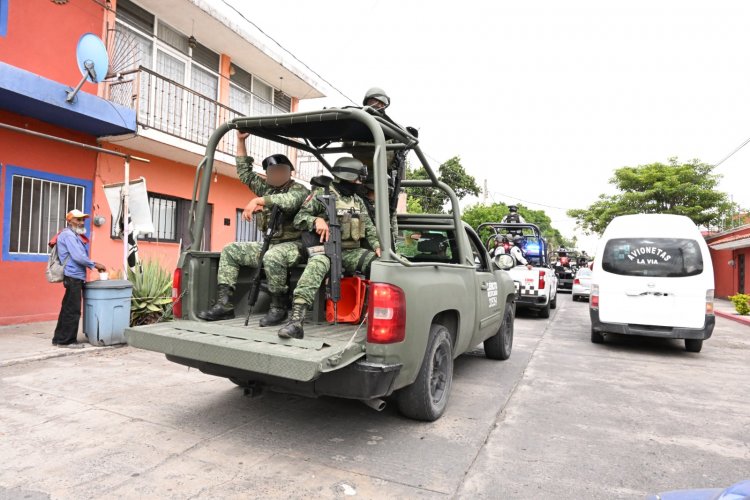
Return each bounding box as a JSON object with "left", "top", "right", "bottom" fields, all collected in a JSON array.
[{"left": 397, "top": 325, "right": 453, "bottom": 422}]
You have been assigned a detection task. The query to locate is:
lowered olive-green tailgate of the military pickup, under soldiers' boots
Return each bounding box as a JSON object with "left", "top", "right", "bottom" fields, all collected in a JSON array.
[{"left": 125, "top": 317, "right": 366, "bottom": 382}]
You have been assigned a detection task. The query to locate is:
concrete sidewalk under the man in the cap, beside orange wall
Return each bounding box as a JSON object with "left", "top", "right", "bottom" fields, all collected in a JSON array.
[{"left": 0, "top": 321, "right": 118, "bottom": 367}]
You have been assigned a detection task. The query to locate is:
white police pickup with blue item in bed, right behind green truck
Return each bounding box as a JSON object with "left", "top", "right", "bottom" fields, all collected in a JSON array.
[{"left": 477, "top": 222, "right": 557, "bottom": 318}]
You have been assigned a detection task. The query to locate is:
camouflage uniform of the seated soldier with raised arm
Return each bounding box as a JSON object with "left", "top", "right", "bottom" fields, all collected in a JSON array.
[{"left": 218, "top": 156, "right": 310, "bottom": 294}]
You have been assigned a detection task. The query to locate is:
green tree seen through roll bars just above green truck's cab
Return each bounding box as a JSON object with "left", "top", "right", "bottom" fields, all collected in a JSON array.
[{"left": 406, "top": 156, "right": 479, "bottom": 214}]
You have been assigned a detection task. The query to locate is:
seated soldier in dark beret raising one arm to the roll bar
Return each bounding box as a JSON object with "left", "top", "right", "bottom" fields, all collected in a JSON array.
[{"left": 198, "top": 132, "right": 310, "bottom": 326}]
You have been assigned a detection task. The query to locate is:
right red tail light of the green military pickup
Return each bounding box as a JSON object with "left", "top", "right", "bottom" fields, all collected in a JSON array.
[{"left": 367, "top": 283, "right": 406, "bottom": 344}]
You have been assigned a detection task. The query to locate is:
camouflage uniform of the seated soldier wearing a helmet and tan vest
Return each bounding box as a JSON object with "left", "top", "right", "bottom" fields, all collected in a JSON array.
[{"left": 294, "top": 183, "right": 380, "bottom": 307}]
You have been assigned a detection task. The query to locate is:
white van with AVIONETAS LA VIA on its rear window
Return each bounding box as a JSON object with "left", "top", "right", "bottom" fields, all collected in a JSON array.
[{"left": 589, "top": 214, "right": 716, "bottom": 352}]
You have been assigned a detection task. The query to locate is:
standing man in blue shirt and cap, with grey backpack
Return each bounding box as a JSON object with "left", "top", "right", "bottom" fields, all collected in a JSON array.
[{"left": 52, "top": 210, "right": 107, "bottom": 348}]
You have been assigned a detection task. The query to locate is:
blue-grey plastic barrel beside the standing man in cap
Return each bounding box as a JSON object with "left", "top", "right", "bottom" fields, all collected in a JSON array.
[{"left": 83, "top": 280, "right": 133, "bottom": 346}]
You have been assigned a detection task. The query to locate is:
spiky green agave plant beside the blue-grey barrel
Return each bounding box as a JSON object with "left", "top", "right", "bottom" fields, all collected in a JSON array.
[{"left": 128, "top": 261, "right": 172, "bottom": 326}]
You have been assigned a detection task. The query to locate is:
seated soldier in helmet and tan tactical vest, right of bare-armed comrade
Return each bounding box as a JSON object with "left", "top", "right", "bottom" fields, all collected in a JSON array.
[{"left": 279, "top": 158, "right": 380, "bottom": 339}]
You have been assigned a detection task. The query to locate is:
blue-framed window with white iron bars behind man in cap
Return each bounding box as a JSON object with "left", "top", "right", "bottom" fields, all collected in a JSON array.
[{"left": 3, "top": 166, "right": 91, "bottom": 261}]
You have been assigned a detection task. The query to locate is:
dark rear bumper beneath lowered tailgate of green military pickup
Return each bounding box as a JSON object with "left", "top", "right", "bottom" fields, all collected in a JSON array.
[{"left": 166, "top": 354, "right": 402, "bottom": 400}]
